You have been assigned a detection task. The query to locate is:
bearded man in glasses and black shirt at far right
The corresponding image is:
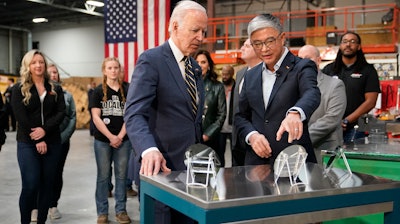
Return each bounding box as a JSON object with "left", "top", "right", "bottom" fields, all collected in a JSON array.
[{"left": 322, "top": 32, "right": 380, "bottom": 143}]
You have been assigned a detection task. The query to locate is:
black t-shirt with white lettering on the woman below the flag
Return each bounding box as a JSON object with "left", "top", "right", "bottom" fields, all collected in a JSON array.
[{"left": 89, "top": 85, "right": 128, "bottom": 142}]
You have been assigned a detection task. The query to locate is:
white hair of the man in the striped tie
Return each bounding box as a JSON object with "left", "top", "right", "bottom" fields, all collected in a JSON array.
[{"left": 168, "top": 0, "right": 207, "bottom": 33}]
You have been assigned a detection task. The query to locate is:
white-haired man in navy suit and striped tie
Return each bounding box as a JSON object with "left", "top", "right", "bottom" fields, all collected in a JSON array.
[{"left": 125, "top": 1, "right": 208, "bottom": 223}]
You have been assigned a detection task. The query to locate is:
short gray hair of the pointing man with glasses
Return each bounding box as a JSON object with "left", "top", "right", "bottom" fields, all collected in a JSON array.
[{"left": 247, "top": 14, "right": 283, "bottom": 37}]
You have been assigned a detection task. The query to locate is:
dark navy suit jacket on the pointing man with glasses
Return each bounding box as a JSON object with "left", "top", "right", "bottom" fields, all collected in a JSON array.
[{"left": 235, "top": 52, "right": 320, "bottom": 165}]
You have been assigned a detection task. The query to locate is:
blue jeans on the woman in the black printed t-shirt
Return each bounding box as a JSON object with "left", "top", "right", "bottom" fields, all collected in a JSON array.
[{"left": 94, "top": 139, "right": 132, "bottom": 215}]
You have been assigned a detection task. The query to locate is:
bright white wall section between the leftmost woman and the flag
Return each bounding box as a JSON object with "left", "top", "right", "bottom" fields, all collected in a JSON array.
[{"left": 32, "top": 21, "right": 104, "bottom": 78}]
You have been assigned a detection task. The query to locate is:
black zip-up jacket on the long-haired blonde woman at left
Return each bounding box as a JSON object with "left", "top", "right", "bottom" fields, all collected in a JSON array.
[{"left": 11, "top": 80, "right": 65, "bottom": 144}]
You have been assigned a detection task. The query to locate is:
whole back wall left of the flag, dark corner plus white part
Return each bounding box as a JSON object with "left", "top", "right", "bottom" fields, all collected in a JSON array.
[{"left": 0, "top": 20, "right": 104, "bottom": 78}]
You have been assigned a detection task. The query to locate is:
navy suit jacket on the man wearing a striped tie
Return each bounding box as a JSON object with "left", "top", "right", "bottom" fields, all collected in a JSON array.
[{"left": 124, "top": 42, "right": 204, "bottom": 170}]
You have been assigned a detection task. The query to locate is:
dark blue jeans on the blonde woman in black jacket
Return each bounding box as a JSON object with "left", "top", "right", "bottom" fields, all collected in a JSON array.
[{"left": 17, "top": 142, "right": 61, "bottom": 224}]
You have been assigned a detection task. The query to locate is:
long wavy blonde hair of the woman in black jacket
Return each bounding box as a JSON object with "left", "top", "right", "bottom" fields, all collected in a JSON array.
[{"left": 19, "top": 49, "right": 57, "bottom": 105}]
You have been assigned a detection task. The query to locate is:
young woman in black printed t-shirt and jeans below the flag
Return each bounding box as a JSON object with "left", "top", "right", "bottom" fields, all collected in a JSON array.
[{"left": 89, "top": 57, "right": 132, "bottom": 224}]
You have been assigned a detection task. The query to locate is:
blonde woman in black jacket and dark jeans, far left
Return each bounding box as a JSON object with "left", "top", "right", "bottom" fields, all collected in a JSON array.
[{"left": 11, "top": 50, "right": 65, "bottom": 224}]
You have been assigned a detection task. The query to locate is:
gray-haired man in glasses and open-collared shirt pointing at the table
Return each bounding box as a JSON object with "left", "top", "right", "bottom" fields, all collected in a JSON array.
[{"left": 235, "top": 14, "right": 321, "bottom": 165}]
